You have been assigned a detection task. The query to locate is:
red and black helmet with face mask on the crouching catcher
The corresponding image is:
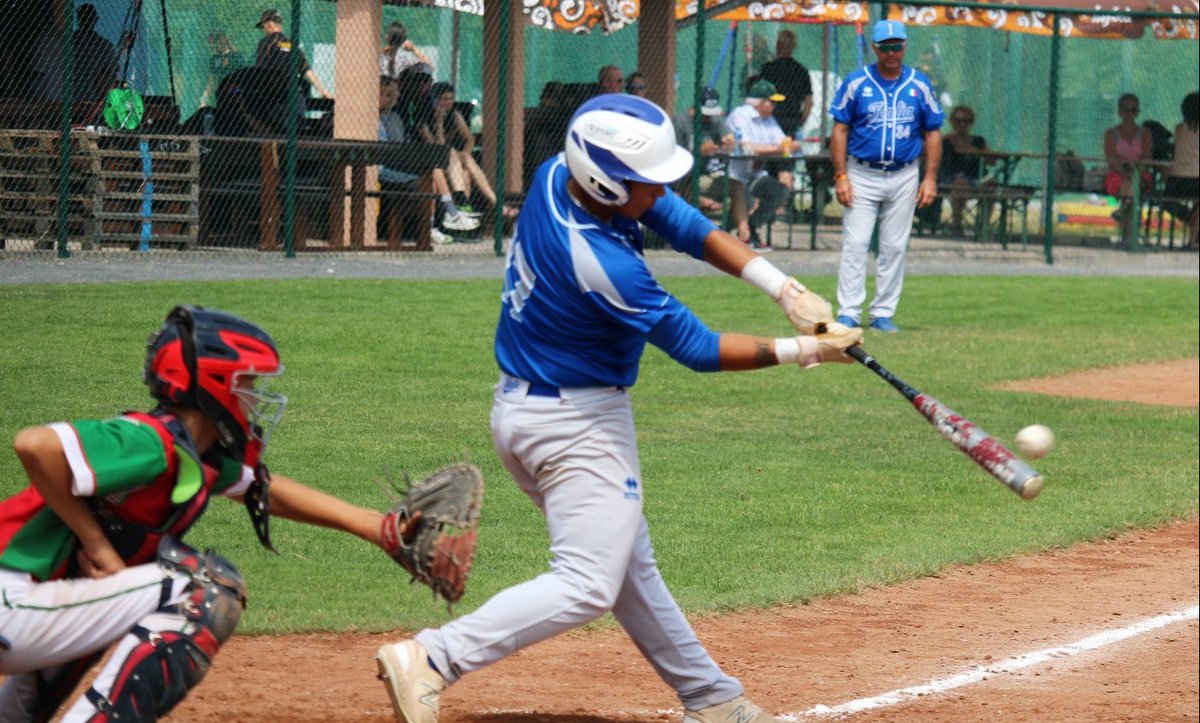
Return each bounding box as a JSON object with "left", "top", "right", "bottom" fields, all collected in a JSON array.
[{"left": 143, "top": 306, "right": 287, "bottom": 467}]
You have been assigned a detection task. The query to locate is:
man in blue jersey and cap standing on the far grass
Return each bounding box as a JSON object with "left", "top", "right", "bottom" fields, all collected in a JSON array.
[{"left": 829, "top": 20, "right": 942, "bottom": 334}]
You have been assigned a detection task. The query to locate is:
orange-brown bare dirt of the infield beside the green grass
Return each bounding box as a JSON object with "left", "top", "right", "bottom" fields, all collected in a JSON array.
[{"left": 170, "top": 360, "right": 1200, "bottom": 723}]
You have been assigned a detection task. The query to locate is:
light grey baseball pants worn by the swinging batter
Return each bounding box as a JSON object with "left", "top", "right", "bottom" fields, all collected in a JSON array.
[{"left": 416, "top": 380, "right": 742, "bottom": 710}]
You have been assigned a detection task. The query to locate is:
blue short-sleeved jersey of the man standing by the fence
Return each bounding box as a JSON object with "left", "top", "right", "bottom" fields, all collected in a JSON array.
[{"left": 829, "top": 65, "right": 943, "bottom": 166}]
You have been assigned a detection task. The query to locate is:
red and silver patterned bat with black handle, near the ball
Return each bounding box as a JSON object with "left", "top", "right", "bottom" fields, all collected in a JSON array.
[{"left": 846, "top": 346, "right": 1043, "bottom": 500}]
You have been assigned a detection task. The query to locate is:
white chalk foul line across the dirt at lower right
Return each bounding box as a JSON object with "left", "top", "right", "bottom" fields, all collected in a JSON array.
[{"left": 779, "top": 607, "right": 1200, "bottom": 721}]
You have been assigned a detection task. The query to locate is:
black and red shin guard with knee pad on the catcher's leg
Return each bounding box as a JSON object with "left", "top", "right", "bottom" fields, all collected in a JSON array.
[{"left": 86, "top": 537, "right": 246, "bottom": 723}]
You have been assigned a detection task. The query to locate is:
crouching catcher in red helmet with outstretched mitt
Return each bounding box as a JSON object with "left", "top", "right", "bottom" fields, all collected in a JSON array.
[{"left": 0, "top": 306, "right": 481, "bottom": 723}]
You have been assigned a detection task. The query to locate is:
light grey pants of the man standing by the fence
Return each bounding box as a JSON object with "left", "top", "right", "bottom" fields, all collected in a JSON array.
[{"left": 838, "top": 164, "right": 919, "bottom": 324}]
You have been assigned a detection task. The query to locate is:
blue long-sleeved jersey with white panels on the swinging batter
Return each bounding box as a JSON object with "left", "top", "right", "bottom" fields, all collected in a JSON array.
[{"left": 496, "top": 154, "right": 719, "bottom": 387}]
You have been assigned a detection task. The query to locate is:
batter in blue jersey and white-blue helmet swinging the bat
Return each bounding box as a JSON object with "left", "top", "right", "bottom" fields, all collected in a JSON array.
[{"left": 376, "top": 94, "right": 862, "bottom": 723}]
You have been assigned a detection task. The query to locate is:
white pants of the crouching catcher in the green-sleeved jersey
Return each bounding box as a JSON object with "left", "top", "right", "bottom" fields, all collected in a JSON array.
[{"left": 0, "top": 563, "right": 188, "bottom": 723}]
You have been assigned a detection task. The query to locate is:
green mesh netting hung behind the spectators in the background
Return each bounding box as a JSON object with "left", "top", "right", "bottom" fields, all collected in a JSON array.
[{"left": 39, "top": 0, "right": 1200, "bottom": 162}]
